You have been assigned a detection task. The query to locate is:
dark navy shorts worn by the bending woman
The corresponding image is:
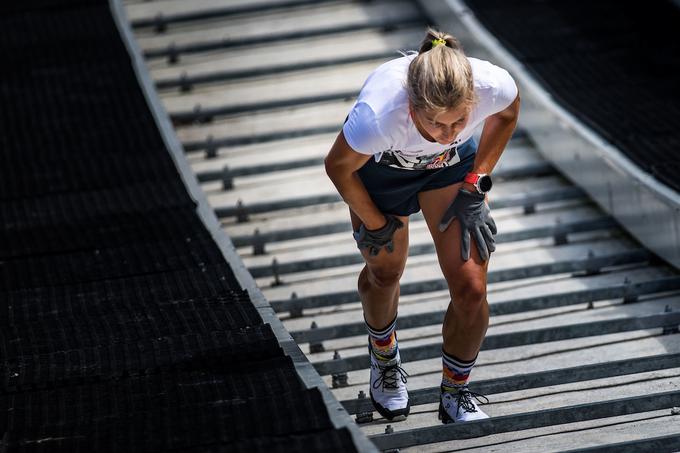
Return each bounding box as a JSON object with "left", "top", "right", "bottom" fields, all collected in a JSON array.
[{"left": 357, "top": 139, "right": 477, "bottom": 216}]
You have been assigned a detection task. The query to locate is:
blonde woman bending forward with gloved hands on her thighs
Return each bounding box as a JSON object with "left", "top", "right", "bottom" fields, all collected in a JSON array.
[{"left": 325, "top": 30, "right": 519, "bottom": 423}]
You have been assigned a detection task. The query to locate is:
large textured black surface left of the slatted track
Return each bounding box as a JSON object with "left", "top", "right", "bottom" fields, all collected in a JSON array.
[{"left": 0, "top": 0, "right": 355, "bottom": 452}]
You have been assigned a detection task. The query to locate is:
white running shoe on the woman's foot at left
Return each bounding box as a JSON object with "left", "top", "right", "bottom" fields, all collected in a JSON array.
[{"left": 369, "top": 347, "right": 411, "bottom": 421}]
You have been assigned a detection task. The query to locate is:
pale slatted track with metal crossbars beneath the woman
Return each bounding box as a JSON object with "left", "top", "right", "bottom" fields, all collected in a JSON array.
[{"left": 128, "top": 0, "right": 680, "bottom": 452}]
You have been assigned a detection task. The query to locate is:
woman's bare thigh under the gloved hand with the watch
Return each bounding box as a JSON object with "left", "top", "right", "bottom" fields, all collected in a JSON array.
[{"left": 418, "top": 182, "right": 488, "bottom": 292}]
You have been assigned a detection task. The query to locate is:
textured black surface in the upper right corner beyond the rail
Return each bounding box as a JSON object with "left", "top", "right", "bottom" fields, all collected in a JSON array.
[{"left": 467, "top": 0, "right": 680, "bottom": 190}]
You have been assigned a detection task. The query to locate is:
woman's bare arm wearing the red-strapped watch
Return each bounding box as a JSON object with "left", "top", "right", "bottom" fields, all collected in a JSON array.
[{"left": 464, "top": 94, "right": 520, "bottom": 192}]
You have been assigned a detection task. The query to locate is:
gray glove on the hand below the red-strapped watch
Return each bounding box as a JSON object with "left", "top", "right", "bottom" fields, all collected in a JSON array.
[{"left": 439, "top": 189, "right": 498, "bottom": 261}]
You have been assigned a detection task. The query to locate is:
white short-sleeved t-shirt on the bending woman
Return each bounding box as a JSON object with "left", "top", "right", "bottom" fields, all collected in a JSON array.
[{"left": 342, "top": 55, "right": 517, "bottom": 161}]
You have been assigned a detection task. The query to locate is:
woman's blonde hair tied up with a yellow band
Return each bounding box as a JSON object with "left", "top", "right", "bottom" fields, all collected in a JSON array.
[{"left": 406, "top": 28, "right": 477, "bottom": 113}]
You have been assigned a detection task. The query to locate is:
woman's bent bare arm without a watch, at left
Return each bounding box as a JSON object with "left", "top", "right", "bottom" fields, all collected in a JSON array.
[{"left": 324, "top": 131, "right": 386, "bottom": 230}]
